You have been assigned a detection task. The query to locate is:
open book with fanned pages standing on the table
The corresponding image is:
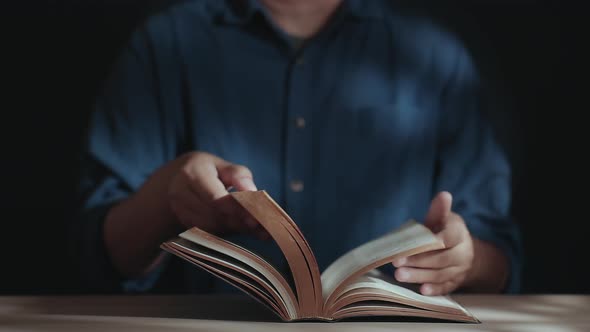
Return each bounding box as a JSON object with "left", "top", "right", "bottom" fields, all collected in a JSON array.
[{"left": 161, "top": 191, "right": 479, "bottom": 323}]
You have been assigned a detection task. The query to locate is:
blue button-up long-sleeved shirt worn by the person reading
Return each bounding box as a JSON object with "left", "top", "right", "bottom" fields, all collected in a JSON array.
[{"left": 77, "top": 0, "right": 520, "bottom": 292}]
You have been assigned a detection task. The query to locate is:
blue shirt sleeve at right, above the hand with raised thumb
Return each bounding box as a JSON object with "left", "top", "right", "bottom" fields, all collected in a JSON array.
[{"left": 435, "top": 44, "right": 522, "bottom": 293}]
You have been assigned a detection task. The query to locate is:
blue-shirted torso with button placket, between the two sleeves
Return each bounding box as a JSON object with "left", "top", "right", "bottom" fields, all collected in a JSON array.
[{"left": 145, "top": 2, "right": 458, "bottom": 287}]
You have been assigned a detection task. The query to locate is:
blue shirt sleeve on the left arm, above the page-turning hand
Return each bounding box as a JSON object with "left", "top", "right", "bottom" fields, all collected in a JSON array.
[{"left": 72, "top": 24, "right": 175, "bottom": 292}]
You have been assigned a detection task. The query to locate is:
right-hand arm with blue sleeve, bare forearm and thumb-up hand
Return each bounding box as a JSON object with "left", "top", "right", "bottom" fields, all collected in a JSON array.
[{"left": 394, "top": 42, "right": 521, "bottom": 295}]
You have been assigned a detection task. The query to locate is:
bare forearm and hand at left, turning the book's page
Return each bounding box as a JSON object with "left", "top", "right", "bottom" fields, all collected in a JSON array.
[{"left": 104, "top": 152, "right": 267, "bottom": 278}]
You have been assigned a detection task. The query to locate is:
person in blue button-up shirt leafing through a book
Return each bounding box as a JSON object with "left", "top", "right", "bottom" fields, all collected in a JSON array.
[{"left": 74, "top": 0, "right": 520, "bottom": 295}]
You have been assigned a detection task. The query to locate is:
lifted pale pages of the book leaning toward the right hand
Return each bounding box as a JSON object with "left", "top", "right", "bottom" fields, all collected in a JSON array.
[{"left": 321, "top": 220, "right": 444, "bottom": 306}]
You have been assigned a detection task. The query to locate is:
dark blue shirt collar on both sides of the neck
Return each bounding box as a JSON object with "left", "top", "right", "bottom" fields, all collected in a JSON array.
[{"left": 214, "top": 0, "right": 386, "bottom": 24}]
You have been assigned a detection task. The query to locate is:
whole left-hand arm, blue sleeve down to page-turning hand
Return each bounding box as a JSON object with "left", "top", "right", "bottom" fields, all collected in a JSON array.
[{"left": 72, "top": 24, "right": 266, "bottom": 292}]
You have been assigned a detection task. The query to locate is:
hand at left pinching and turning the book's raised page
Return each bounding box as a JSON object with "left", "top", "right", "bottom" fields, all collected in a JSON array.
[{"left": 140, "top": 152, "right": 269, "bottom": 239}]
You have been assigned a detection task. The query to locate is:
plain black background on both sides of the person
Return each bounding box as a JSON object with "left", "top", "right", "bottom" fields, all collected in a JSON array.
[{"left": 0, "top": 0, "right": 590, "bottom": 294}]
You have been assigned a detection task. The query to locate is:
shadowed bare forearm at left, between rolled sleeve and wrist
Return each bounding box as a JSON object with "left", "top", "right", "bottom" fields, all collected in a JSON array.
[{"left": 104, "top": 188, "right": 181, "bottom": 278}]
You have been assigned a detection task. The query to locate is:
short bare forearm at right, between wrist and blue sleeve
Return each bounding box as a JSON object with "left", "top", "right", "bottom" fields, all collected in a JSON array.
[{"left": 461, "top": 238, "right": 510, "bottom": 293}]
